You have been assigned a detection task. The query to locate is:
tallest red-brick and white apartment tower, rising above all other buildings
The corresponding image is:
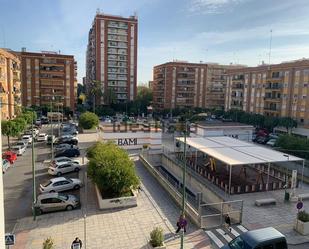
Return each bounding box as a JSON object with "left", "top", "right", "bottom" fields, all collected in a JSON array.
[{"left": 86, "top": 13, "right": 138, "bottom": 104}]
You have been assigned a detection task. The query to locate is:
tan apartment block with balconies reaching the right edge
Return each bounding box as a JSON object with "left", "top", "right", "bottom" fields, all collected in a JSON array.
[{"left": 225, "top": 59, "right": 309, "bottom": 125}]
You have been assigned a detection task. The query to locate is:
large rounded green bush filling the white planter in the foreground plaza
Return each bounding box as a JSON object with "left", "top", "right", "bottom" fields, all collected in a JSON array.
[{"left": 87, "top": 142, "right": 139, "bottom": 198}]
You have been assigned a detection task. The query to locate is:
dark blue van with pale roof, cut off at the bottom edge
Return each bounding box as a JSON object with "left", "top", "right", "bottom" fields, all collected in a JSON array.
[{"left": 222, "top": 227, "right": 288, "bottom": 249}]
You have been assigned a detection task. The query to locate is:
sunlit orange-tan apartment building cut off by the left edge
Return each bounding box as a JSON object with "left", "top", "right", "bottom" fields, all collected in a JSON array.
[{"left": 0, "top": 49, "right": 21, "bottom": 120}]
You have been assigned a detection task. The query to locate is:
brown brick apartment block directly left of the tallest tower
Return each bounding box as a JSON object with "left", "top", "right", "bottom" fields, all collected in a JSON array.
[{"left": 18, "top": 48, "right": 77, "bottom": 111}]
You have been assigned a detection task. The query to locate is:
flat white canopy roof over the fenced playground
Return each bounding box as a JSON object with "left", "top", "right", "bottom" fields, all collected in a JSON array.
[{"left": 177, "top": 136, "right": 304, "bottom": 165}]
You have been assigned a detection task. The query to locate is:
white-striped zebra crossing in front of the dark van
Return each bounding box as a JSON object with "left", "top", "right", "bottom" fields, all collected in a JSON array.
[{"left": 205, "top": 225, "right": 248, "bottom": 248}]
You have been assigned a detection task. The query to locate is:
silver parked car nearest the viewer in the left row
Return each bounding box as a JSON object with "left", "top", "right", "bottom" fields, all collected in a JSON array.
[{"left": 34, "top": 193, "right": 80, "bottom": 214}]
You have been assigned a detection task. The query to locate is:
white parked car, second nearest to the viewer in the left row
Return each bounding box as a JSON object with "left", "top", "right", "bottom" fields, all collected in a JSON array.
[{"left": 40, "top": 177, "right": 83, "bottom": 193}]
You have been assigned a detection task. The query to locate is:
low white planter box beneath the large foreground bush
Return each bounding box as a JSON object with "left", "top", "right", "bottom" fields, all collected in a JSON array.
[{"left": 95, "top": 185, "right": 137, "bottom": 210}]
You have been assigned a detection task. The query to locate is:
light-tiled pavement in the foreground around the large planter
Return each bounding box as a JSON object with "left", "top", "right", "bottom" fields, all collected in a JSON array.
[{"left": 11, "top": 158, "right": 211, "bottom": 249}]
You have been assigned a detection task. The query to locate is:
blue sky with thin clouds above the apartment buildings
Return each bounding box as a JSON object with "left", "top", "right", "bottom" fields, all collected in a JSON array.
[{"left": 0, "top": 0, "right": 309, "bottom": 84}]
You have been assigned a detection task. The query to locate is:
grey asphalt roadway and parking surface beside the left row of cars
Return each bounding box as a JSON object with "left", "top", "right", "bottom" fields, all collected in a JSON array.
[{"left": 3, "top": 125, "right": 80, "bottom": 232}]
